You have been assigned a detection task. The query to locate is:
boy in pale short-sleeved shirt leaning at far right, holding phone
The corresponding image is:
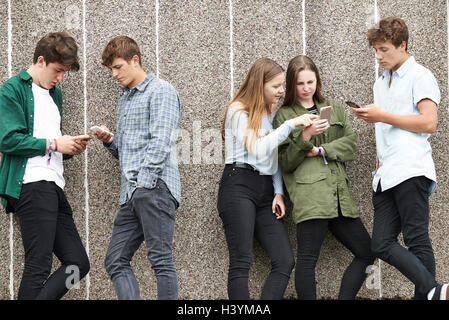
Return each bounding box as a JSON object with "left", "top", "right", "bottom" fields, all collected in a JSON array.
[{"left": 351, "top": 17, "right": 449, "bottom": 300}]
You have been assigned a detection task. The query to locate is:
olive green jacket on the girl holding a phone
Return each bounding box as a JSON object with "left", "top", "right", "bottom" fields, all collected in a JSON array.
[{"left": 273, "top": 99, "right": 359, "bottom": 223}]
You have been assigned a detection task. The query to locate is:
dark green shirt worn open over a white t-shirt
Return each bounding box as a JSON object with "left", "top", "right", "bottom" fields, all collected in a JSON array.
[{"left": 0, "top": 70, "right": 71, "bottom": 212}]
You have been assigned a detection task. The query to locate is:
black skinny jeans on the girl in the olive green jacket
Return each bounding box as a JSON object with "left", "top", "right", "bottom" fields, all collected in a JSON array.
[{"left": 295, "top": 213, "right": 375, "bottom": 300}]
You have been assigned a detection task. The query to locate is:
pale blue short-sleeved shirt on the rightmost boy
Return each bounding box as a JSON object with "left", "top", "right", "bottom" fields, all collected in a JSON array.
[{"left": 373, "top": 57, "right": 441, "bottom": 193}]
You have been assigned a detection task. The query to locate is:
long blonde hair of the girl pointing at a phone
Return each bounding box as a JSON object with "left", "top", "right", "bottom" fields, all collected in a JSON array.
[{"left": 221, "top": 58, "right": 284, "bottom": 152}]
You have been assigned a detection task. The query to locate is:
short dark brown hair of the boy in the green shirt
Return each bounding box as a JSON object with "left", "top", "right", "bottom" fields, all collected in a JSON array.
[{"left": 33, "top": 32, "right": 80, "bottom": 71}]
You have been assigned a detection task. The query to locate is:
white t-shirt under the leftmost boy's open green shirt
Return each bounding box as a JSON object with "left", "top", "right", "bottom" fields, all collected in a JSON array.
[{"left": 23, "top": 83, "right": 65, "bottom": 189}]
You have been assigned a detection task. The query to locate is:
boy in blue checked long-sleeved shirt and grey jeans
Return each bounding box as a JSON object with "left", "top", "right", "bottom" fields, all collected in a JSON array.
[{"left": 94, "top": 36, "right": 181, "bottom": 300}]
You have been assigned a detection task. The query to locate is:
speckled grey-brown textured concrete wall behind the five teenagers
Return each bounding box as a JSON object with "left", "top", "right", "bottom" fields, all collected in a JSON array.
[{"left": 0, "top": 0, "right": 449, "bottom": 299}]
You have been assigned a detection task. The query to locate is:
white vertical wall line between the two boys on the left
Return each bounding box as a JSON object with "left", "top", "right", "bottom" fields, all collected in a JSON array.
[{"left": 83, "top": 0, "right": 90, "bottom": 300}]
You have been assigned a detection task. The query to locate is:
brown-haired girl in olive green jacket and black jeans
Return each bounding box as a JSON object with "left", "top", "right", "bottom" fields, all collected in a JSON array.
[{"left": 273, "top": 56, "right": 374, "bottom": 299}]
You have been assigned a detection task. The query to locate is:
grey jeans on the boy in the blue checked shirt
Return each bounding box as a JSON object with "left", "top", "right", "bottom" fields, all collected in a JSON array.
[{"left": 105, "top": 179, "right": 178, "bottom": 300}]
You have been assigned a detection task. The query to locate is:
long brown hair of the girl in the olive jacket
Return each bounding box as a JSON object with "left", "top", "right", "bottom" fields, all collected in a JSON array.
[{"left": 282, "top": 55, "right": 325, "bottom": 107}]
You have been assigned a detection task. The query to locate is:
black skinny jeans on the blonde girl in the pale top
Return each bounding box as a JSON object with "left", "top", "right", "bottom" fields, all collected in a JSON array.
[{"left": 217, "top": 165, "right": 294, "bottom": 300}]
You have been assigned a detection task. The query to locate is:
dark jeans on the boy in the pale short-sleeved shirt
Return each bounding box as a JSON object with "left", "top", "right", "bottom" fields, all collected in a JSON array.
[{"left": 372, "top": 176, "right": 437, "bottom": 299}]
